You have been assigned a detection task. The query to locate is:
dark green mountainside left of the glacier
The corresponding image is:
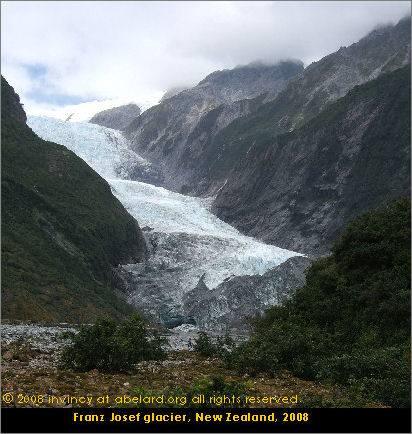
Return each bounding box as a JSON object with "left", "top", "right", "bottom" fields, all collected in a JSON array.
[{"left": 1, "top": 78, "right": 146, "bottom": 322}]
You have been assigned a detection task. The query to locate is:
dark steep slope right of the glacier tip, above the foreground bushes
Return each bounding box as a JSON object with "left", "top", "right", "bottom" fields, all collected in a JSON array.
[{"left": 213, "top": 65, "right": 411, "bottom": 255}]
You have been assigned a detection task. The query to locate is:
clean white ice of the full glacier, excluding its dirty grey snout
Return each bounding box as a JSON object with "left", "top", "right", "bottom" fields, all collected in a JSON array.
[{"left": 28, "top": 116, "right": 301, "bottom": 298}]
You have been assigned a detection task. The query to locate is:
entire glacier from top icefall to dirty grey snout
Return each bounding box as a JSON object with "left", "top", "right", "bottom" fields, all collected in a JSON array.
[{"left": 27, "top": 116, "right": 304, "bottom": 326}]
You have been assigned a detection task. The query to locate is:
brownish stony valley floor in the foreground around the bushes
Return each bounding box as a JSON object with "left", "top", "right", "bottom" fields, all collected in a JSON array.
[{"left": 1, "top": 326, "right": 383, "bottom": 408}]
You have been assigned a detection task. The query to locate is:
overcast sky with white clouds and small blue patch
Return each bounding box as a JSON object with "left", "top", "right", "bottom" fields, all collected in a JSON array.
[{"left": 1, "top": 1, "right": 410, "bottom": 111}]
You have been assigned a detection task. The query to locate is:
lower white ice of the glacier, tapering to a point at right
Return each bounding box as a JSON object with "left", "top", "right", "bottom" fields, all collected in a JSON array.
[{"left": 108, "top": 179, "right": 298, "bottom": 288}]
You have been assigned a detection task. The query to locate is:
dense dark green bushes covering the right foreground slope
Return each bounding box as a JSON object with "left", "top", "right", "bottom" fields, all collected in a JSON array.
[{"left": 229, "top": 198, "right": 411, "bottom": 407}]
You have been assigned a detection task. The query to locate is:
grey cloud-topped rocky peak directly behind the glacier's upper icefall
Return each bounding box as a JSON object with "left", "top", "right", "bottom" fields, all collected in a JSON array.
[{"left": 125, "top": 62, "right": 303, "bottom": 192}]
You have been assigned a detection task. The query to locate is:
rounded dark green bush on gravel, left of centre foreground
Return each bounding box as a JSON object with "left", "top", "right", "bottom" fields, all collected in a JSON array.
[{"left": 60, "top": 313, "right": 166, "bottom": 373}]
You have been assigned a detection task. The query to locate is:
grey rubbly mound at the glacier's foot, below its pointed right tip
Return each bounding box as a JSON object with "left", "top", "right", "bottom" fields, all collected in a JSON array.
[{"left": 184, "top": 256, "right": 310, "bottom": 331}]
